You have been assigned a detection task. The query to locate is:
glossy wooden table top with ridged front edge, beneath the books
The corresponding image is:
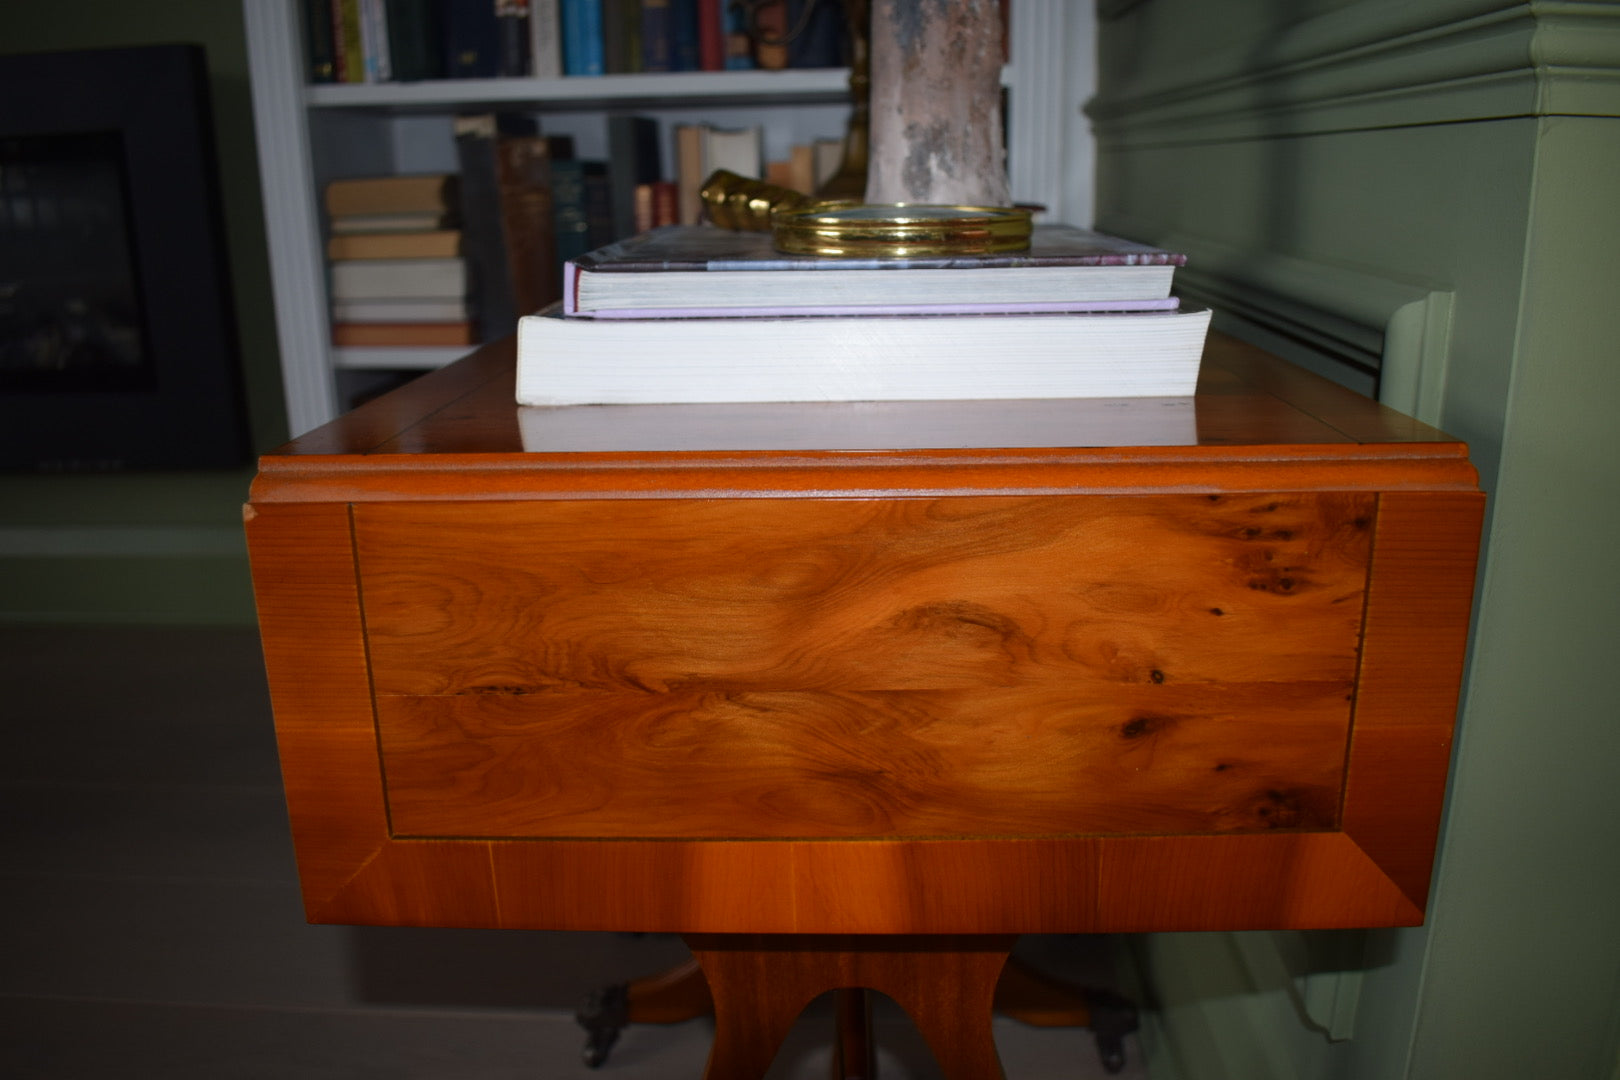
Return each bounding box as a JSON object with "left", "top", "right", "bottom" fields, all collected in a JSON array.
[{"left": 253, "top": 334, "right": 1474, "bottom": 502}]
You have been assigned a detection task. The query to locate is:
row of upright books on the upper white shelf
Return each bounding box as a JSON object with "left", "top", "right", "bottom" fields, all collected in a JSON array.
[{"left": 303, "top": 0, "right": 849, "bottom": 83}]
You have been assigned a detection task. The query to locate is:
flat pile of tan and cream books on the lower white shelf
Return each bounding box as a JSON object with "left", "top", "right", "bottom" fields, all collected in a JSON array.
[{"left": 326, "top": 173, "right": 475, "bottom": 347}]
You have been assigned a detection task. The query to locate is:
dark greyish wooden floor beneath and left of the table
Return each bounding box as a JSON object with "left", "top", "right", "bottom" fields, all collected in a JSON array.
[{"left": 0, "top": 627, "right": 1147, "bottom": 1080}]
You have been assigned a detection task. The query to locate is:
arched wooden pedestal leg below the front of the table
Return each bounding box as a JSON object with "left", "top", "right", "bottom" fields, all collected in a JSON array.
[{"left": 687, "top": 934, "right": 1016, "bottom": 1080}]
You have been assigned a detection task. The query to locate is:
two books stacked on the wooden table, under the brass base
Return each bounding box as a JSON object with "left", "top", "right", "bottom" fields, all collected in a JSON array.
[{"left": 517, "top": 225, "right": 1210, "bottom": 405}]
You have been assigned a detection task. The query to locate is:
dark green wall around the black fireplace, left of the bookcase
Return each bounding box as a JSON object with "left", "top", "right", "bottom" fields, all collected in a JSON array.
[{"left": 0, "top": 0, "right": 287, "bottom": 623}]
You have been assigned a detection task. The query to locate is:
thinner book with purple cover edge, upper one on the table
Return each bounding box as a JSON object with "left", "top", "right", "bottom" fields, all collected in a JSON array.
[{"left": 562, "top": 225, "right": 1186, "bottom": 319}]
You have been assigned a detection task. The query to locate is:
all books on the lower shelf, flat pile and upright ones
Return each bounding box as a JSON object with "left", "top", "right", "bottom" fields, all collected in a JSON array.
[{"left": 326, "top": 112, "right": 861, "bottom": 347}]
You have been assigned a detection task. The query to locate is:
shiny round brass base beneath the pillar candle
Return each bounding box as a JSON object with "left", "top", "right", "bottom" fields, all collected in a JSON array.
[{"left": 771, "top": 202, "right": 1032, "bottom": 257}]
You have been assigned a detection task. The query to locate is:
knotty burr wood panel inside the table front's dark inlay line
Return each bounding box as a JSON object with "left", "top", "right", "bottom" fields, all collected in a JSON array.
[{"left": 353, "top": 494, "right": 1377, "bottom": 839}]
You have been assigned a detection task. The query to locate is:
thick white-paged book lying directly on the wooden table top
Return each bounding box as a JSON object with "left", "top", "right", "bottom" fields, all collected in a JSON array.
[{"left": 517, "top": 306, "right": 1210, "bottom": 405}]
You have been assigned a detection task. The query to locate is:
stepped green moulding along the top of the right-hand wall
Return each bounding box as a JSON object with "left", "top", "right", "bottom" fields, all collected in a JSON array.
[{"left": 1085, "top": 0, "right": 1620, "bottom": 147}]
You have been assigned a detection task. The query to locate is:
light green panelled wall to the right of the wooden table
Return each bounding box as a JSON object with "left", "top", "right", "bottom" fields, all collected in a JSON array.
[{"left": 1092, "top": 0, "right": 1620, "bottom": 1080}]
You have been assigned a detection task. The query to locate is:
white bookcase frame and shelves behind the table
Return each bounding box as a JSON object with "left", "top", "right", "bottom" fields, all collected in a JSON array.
[{"left": 243, "top": 0, "right": 1092, "bottom": 436}]
